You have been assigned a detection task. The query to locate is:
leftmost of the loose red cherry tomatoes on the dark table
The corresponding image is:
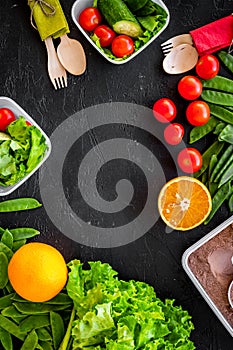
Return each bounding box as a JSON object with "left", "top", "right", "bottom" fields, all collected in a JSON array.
[{"left": 153, "top": 97, "right": 177, "bottom": 123}]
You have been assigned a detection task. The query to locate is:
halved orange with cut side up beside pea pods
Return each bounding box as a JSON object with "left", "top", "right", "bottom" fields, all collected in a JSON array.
[{"left": 158, "top": 176, "right": 212, "bottom": 231}]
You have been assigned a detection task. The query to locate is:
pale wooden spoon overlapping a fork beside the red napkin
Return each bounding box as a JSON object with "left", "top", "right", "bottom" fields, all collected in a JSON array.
[{"left": 163, "top": 44, "right": 198, "bottom": 74}]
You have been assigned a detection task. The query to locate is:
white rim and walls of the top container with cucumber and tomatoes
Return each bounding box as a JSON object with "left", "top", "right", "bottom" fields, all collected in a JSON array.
[{"left": 71, "top": 0, "right": 170, "bottom": 64}]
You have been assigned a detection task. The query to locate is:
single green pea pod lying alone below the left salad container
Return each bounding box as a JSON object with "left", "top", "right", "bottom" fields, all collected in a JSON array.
[{"left": 0, "top": 198, "right": 41, "bottom": 213}]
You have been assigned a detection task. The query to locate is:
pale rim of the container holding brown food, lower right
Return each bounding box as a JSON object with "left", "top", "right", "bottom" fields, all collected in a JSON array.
[{"left": 182, "top": 216, "right": 233, "bottom": 337}]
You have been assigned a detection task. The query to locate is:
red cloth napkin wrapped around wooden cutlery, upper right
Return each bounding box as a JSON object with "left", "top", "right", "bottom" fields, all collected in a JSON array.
[{"left": 190, "top": 15, "right": 233, "bottom": 56}]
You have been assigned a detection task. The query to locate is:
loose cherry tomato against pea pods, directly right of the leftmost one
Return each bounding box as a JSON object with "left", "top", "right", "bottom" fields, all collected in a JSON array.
[{"left": 186, "top": 100, "right": 210, "bottom": 126}]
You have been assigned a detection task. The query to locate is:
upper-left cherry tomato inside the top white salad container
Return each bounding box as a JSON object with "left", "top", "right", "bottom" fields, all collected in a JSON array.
[{"left": 79, "top": 7, "right": 102, "bottom": 32}]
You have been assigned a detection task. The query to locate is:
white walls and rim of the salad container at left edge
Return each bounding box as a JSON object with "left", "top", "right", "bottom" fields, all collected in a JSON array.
[{"left": 0, "top": 96, "right": 51, "bottom": 196}]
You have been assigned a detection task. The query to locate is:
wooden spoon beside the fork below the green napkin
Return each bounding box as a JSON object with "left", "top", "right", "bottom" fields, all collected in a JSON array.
[{"left": 57, "top": 34, "right": 86, "bottom": 75}]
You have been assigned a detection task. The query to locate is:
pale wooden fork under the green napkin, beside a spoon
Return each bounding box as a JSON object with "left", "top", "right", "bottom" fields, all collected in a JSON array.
[{"left": 44, "top": 37, "right": 67, "bottom": 90}]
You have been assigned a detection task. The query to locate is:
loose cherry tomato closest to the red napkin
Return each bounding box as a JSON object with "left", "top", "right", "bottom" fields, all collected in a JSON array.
[{"left": 196, "top": 55, "right": 219, "bottom": 79}]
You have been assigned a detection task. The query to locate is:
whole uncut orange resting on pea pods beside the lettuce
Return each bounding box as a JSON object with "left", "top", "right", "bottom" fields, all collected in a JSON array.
[{"left": 8, "top": 242, "right": 68, "bottom": 302}]
